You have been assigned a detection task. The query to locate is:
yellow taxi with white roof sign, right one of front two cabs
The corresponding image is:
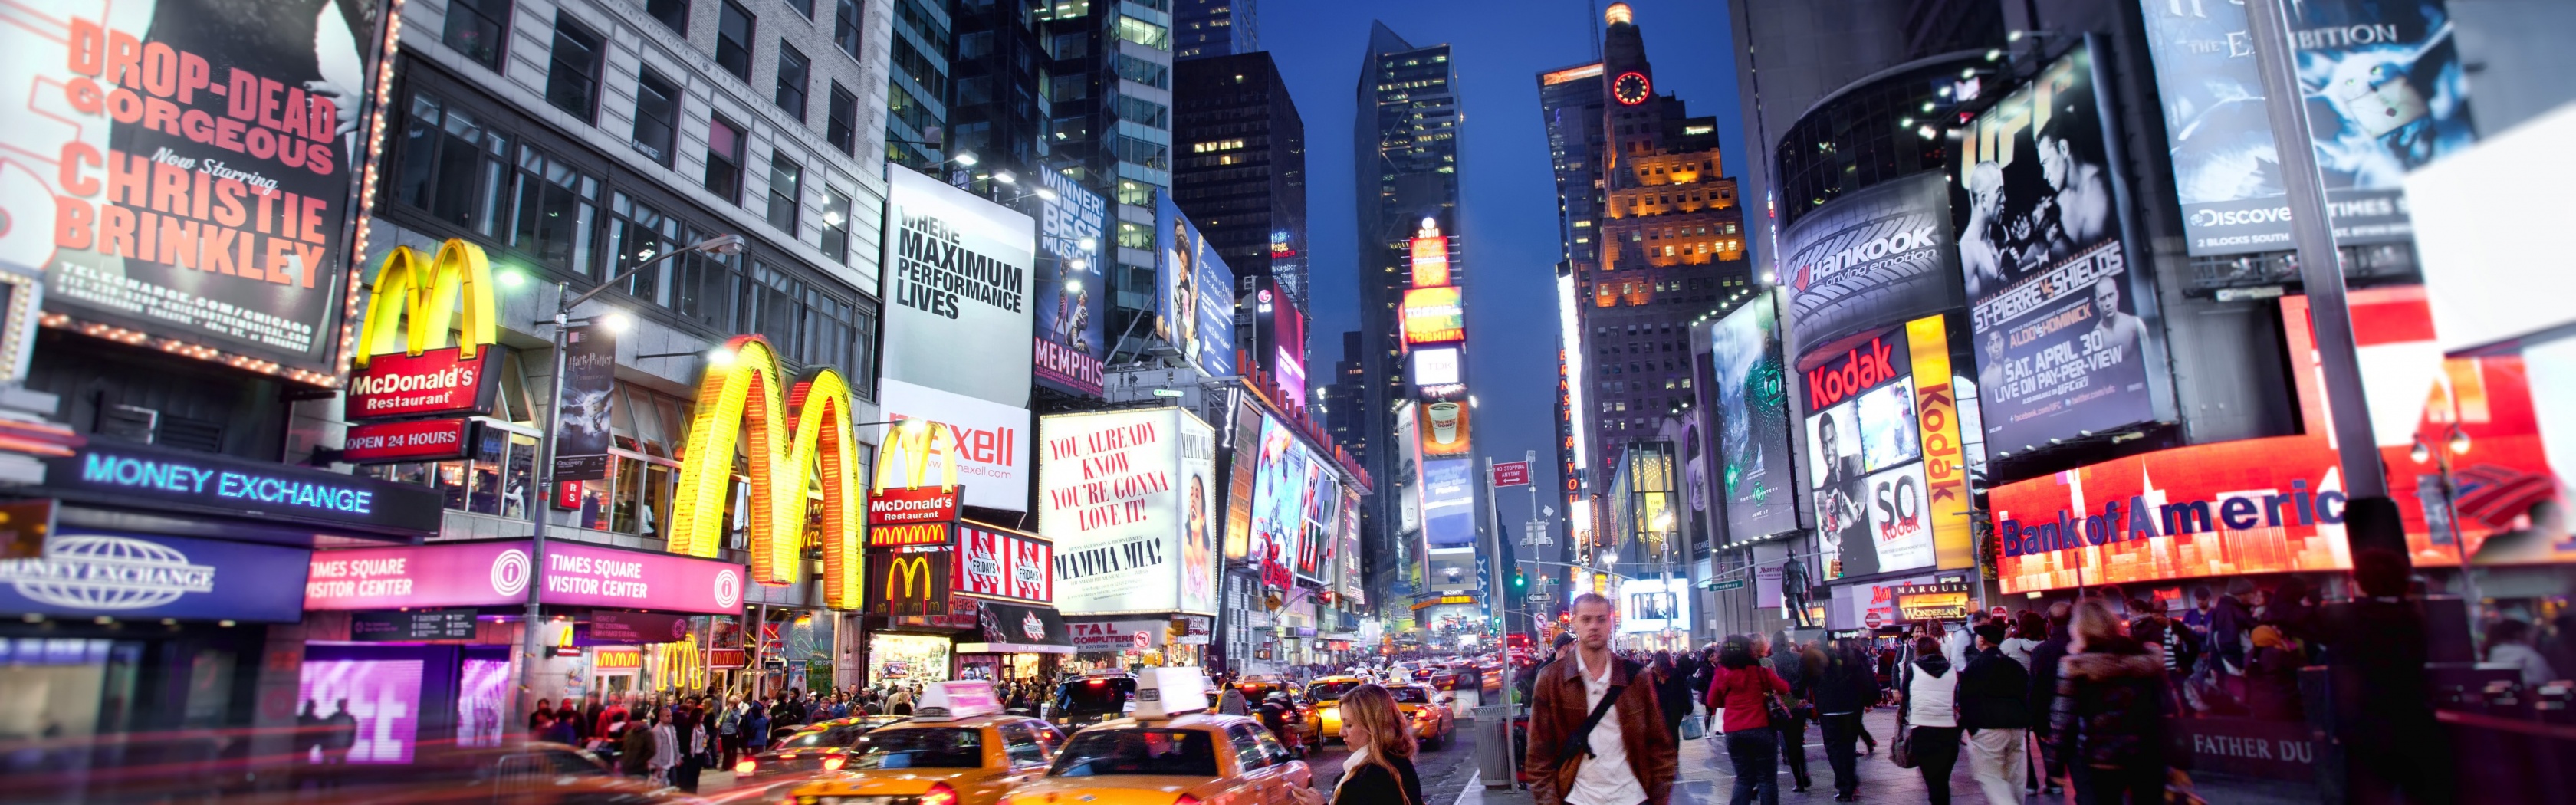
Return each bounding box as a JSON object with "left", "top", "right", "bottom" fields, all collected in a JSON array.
[{"left": 994, "top": 669, "right": 1314, "bottom": 805}]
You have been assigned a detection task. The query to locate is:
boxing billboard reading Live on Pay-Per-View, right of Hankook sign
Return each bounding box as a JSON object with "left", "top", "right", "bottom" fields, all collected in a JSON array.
[{"left": 1950, "top": 44, "right": 2164, "bottom": 452}]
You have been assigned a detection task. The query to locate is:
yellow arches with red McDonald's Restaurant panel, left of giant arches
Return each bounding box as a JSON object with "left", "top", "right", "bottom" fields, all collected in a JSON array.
[{"left": 343, "top": 240, "right": 502, "bottom": 421}]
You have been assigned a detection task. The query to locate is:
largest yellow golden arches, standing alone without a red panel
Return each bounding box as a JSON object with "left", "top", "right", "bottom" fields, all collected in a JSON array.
[{"left": 670, "top": 336, "right": 866, "bottom": 609}]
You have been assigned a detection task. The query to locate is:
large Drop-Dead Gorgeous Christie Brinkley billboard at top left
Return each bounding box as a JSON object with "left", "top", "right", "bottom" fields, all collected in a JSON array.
[{"left": 0, "top": 0, "right": 379, "bottom": 374}]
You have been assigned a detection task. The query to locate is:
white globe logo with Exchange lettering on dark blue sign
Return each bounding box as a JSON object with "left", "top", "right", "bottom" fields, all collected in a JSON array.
[{"left": 0, "top": 534, "right": 214, "bottom": 609}]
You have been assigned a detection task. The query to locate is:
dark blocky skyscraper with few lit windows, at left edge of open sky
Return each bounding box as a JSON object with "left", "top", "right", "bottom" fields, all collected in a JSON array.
[{"left": 1172, "top": 51, "right": 1309, "bottom": 312}]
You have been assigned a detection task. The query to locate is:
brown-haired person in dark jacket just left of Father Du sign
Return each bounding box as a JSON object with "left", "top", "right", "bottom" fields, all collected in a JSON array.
[{"left": 2048, "top": 601, "right": 2164, "bottom": 803}]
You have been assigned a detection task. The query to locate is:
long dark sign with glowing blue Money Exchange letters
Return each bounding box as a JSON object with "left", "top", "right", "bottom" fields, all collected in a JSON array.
[{"left": 44, "top": 444, "right": 441, "bottom": 534}]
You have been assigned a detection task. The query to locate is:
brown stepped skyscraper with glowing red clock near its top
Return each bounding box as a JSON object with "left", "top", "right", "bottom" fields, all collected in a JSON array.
[{"left": 1540, "top": 2, "right": 1752, "bottom": 521}]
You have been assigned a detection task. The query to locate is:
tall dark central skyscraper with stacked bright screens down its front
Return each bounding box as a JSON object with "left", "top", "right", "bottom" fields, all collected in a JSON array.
[{"left": 1352, "top": 23, "right": 1474, "bottom": 622}]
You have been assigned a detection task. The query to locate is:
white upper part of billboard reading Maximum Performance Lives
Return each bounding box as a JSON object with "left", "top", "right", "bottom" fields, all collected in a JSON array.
[{"left": 883, "top": 170, "right": 1036, "bottom": 408}]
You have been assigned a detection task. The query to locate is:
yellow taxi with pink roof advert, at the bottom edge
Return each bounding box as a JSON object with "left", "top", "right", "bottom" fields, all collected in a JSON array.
[{"left": 780, "top": 681, "right": 1064, "bottom": 805}]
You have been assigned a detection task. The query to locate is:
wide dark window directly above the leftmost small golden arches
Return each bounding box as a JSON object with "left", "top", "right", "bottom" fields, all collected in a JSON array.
[{"left": 394, "top": 93, "right": 510, "bottom": 238}]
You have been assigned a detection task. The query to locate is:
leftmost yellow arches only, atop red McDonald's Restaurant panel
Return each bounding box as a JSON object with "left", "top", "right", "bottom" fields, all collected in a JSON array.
[{"left": 356, "top": 238, "right": 500, "bottom": 369}]
